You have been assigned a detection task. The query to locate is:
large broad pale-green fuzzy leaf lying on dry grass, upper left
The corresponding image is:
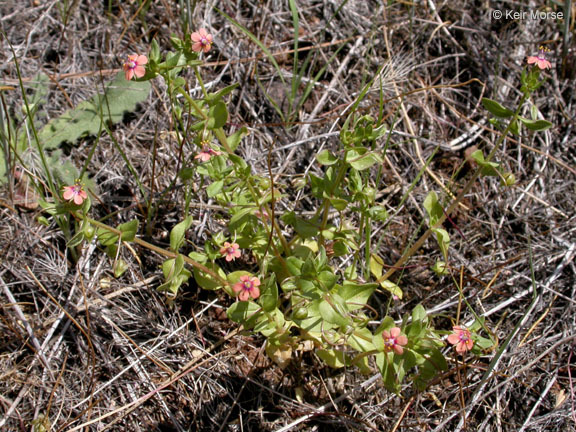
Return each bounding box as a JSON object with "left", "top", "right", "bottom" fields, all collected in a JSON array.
[{"left": 38, "top": 72, "right": 150, "bottom": 150}]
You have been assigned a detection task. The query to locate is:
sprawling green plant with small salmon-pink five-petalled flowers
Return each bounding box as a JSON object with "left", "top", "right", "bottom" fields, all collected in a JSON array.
[{"left": 35, "top": 29, "right": 551, "bottom": 392}]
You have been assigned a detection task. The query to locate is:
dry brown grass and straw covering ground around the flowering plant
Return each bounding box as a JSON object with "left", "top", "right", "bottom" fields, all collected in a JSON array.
[{"left": 0, "top": 0, "right": 576, "bottom": 431}]
